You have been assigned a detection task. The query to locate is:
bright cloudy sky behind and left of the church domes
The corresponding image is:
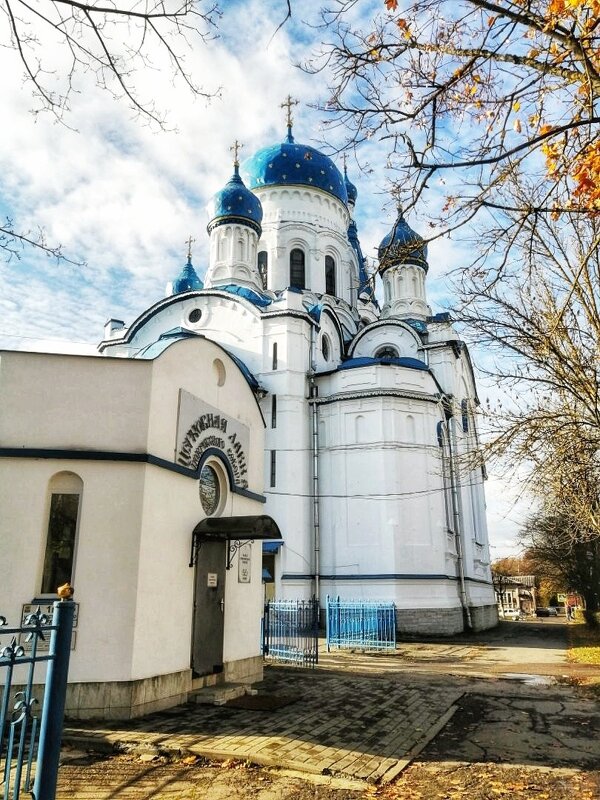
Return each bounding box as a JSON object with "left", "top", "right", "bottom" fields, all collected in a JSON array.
[{"left": 0, "top": 0, "right": 523, "bottom": 559}]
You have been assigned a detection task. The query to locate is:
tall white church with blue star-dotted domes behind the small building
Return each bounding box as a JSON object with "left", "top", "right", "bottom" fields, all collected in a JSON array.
[{"left": 99, "top": 109, "right": 497, "bottom": 634}]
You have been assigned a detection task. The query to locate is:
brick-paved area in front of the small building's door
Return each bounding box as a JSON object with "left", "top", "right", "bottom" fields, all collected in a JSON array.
[{"left": 63, "top": 667, "right": 462, "bottom": 782}]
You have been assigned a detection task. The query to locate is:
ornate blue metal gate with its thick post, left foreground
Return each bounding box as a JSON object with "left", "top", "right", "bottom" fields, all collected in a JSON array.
[{"left": 0, "top": 600, "right": 75, "bottom": 800}]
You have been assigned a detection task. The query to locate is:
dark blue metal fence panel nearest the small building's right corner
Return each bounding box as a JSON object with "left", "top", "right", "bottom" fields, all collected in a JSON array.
[{"left": 263, "top": 598, "right": 319, "bottom": 667}]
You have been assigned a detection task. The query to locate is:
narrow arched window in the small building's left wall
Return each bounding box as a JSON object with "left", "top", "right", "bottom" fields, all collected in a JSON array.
[{"left": 42, "top": 472, "right": 83, "bottom": 594}]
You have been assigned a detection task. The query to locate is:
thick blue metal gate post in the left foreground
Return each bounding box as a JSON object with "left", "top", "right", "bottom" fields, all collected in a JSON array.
[{"left": 32, "top": 600, "right": 75, "bottom": 800}]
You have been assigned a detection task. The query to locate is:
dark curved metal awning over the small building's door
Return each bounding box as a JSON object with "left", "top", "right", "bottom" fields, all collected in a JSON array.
[{"left": 190, "top": 514, "right": 282, "bottom": 569}]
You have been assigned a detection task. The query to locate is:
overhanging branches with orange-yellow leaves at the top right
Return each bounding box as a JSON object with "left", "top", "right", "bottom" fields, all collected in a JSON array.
[{"left": 322, "top": 0, "right": 600, "bottom": 228}]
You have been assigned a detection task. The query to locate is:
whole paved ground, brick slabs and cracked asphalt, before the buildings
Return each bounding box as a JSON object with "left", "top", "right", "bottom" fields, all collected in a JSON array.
[{"left": 65, "top": 623, "right": 600, "bottom": 782}]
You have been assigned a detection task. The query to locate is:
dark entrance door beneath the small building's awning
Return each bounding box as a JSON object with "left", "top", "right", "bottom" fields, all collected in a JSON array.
[{"left": 192, "top": 541, "right": 227, "bottom": 675}]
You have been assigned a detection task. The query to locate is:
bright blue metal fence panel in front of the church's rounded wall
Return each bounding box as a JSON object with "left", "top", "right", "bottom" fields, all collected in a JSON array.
[{"left": 326, "top": 596, "right": 396, "bottom": 652}]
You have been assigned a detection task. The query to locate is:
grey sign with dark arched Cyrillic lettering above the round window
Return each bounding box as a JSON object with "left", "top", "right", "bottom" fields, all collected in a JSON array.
[{"left": 175, "top": 389, "right": 250, "bottom": 489}]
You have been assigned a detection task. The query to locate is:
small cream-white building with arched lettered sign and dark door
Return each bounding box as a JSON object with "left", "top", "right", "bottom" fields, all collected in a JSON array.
[{"left": 0, "top": 337, "right": 278, "bottom": 718}]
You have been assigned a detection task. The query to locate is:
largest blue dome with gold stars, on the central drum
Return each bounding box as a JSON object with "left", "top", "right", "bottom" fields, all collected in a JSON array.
[{"left": 241, "top": 135, "right": 348, "bottom": 205}]
